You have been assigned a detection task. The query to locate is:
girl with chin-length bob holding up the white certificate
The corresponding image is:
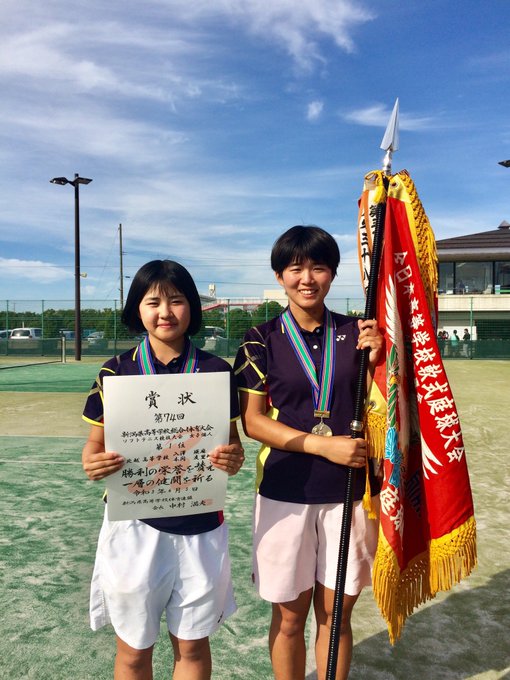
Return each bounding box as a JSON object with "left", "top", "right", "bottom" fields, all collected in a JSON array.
[{"left": 82, "top": 260, "right": 244, "bottom": 680}]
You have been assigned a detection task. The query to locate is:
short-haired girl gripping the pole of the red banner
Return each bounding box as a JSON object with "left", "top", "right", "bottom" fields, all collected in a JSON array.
[{"left": 235, "top": 226, "right": 383, "bottom": 680}]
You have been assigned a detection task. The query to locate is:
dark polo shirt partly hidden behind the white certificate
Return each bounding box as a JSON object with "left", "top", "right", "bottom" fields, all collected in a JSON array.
[{"left": 82, "top": 340, "right": 239, "bottom": 535}]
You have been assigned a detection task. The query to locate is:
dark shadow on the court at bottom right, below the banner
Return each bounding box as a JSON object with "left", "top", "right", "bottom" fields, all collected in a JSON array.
[{"left": 349, "top": 569, "right": 510, "bottom": 680}]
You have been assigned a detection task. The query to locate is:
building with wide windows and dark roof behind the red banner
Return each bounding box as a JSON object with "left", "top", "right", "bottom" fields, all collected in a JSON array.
[{"left": 437, "top": 222, "right": 510, "bottom": 356}]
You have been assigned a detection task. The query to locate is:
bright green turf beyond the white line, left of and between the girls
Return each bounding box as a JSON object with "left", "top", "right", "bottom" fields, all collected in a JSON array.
[{"left": 0, "top": 437, "right": 270, "bottom": 680}]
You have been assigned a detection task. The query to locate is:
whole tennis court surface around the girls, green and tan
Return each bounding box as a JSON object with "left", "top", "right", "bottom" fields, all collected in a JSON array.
[{"left": 0, "top": 360, "right": 510, "bottom": 680}]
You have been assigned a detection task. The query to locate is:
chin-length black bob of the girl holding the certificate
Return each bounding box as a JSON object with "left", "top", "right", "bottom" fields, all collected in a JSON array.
[{"left": 121, "top": 260, "right": 202, "bottom": 336}]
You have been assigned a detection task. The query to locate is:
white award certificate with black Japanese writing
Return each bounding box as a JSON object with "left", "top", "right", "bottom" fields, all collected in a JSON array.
[{"left": 104, "top": 372, "right": 230, "bottom": 520}]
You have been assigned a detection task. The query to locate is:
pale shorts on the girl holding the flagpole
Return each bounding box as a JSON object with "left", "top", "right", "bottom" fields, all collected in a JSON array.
[{"left": 253, "top": 494, "right": 379, "bottom": 602}]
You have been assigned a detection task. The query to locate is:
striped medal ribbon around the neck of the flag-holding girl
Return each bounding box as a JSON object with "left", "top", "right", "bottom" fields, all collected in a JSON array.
[{"left": 280, "top": 307, "right": 336, "bottom": 418}]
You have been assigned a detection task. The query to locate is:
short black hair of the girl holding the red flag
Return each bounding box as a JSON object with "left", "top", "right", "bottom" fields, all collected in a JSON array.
[{"left": 271, "top": 225, "right": 340, "bottom": 277}]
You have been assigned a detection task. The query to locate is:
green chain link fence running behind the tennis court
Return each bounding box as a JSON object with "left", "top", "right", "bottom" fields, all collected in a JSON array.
[{"left": 0, "top": 296, "right": 510, "bottom": 359}]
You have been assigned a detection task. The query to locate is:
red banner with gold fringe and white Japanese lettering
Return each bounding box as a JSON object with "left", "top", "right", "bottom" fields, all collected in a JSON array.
[{"left": 359, "top": 172, "right": 476, "bottom": 642}]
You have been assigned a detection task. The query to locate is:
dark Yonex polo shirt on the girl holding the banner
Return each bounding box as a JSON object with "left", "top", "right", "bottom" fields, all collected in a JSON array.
[{"left": 234, "top": 312, "right": 379, "bottom": 503}]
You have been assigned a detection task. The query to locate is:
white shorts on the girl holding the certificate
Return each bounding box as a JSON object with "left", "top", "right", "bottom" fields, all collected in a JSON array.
[{"left": 90, "top": 513, "right": 236, "bottom": 649}]
